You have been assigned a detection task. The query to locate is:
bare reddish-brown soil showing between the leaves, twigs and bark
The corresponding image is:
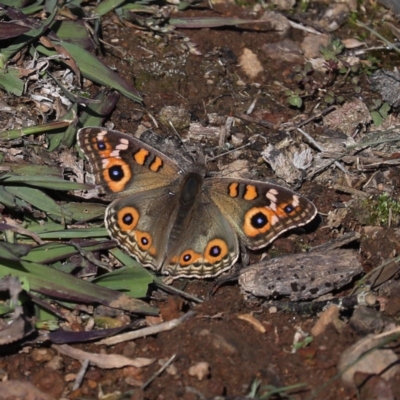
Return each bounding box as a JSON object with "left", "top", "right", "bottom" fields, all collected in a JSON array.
[{"left": 0, "top": 2, "right": 400, "bottom": 400}]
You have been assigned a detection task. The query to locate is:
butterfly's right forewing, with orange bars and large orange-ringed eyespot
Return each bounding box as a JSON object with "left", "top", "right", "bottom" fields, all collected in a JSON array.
[{"left": 204, "top": 178, "right": 317, "bottom": 249}]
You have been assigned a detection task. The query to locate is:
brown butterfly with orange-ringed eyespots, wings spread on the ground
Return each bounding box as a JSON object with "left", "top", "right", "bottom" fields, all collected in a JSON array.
[{"left": 78, "top": 127, "right": 317, "bottom": 278}]
